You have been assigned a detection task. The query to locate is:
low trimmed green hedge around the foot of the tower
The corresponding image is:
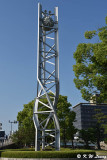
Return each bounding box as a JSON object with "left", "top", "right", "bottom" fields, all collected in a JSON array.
[{"left": 0, "top": 150, "right": 96, "bottom": 158}]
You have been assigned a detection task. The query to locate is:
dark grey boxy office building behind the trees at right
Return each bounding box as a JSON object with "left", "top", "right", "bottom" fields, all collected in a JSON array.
[{"left": 73, "top": 103, "right": 107, "bottom": 130}]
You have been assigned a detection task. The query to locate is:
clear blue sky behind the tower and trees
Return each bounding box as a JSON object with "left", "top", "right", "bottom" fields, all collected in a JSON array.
[{"left": 0, "top": 0, "right": 107, "bottom": 134}]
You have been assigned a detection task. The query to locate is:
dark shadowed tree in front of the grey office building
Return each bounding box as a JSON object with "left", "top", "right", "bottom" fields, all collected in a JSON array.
[{"left": 79, "top": 109, "right": 107, "bottom": 149}]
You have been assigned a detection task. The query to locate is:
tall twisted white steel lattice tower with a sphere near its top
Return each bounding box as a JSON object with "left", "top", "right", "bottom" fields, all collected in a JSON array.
[{"left": 33, "top": 3, "right": 60, "bottom": 151}]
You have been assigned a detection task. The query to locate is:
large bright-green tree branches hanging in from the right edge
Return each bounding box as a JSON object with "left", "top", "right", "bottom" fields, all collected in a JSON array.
[{"left": 73, "top": 17, "right": 107, "bottom": 103}]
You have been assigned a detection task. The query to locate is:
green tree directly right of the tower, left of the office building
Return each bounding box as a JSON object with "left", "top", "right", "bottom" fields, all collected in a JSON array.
[{"left": 57, "top": 95, "right": 77, "bottom": 147}]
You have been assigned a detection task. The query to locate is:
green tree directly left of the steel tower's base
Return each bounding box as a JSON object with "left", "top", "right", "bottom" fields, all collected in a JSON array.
[{"left": 12, "top": 100, "right": 35, "bottom": 147}]
